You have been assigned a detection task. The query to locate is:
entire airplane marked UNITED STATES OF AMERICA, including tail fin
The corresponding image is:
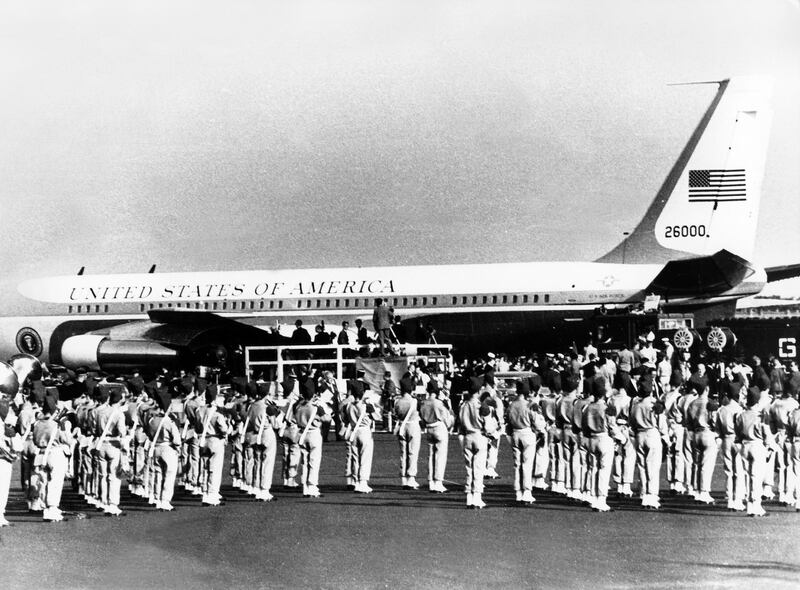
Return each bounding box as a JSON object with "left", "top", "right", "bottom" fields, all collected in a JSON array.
[{"left": 0, "top": 78, "right": 800, "bottom": 370}]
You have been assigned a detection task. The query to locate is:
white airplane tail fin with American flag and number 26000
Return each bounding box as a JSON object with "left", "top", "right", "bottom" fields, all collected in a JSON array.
[{"left": 598, "top": 78, "right": 772, "bottom": 264}]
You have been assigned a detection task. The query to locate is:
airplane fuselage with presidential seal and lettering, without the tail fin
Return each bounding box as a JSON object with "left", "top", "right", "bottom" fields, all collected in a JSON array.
[{"left": 0, "top": 262, "right": 765, "bottom": 362}]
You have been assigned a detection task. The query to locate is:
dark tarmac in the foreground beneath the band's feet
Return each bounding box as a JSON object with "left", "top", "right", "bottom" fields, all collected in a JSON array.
[{"left": 0, "top": 433, "right": 800, "bottom": 590}]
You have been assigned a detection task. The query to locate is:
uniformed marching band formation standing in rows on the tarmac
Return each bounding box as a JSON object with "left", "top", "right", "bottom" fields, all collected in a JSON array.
[{"left": 0, "top": 333, "right": 800, "bottom": 526}]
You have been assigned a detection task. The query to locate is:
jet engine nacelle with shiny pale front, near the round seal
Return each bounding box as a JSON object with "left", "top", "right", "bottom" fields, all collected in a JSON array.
[{"left": 61, "top": 334, "right": 183, "bottom": 371}]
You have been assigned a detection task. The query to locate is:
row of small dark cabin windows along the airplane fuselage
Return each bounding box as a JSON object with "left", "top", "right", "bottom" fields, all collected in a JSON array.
[{"left": 69, "top": 294, "right": 550, "bottom": 313}]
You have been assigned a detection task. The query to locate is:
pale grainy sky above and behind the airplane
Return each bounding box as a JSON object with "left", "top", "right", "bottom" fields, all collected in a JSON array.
[{"left": 0, "top": 0, "right": 800, "bottom": 312}]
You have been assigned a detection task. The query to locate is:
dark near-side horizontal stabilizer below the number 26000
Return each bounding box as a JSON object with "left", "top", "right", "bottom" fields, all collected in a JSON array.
[{"left": 646, "top": 250, "right": 755, "bottom": 299}]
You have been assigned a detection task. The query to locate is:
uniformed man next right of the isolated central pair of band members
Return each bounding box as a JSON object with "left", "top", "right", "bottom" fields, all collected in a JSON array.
[{"left": 458, "top": 377, "right": 490, "bottom": 508}]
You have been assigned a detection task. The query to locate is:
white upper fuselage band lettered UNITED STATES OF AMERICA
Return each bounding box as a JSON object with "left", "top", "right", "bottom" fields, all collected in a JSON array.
[{"left": 19, "top": 262, "right": 662, "bottom": 304}]
